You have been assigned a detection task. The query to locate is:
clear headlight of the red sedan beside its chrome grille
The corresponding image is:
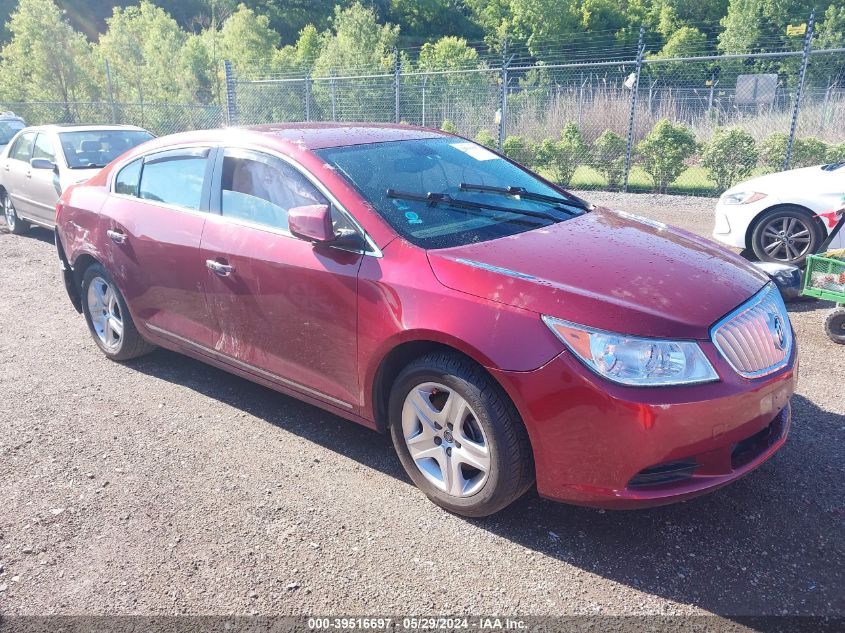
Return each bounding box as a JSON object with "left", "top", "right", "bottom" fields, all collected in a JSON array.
[{"left": 543, "top": 315, "right": 719, "bottom": 387}]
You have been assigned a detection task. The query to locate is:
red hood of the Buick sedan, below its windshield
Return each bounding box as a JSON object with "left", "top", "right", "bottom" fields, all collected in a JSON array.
[{"left": 428, "top": 209, "right": 768, "bottom": 339}]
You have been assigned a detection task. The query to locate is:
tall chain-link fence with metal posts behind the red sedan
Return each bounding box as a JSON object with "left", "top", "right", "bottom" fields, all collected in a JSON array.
[{"left": 227, "top": 35, "right": 845, "bottom": 195}]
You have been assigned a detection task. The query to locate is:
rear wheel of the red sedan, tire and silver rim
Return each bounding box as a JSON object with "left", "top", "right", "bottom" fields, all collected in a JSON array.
[{"left": 82, "top": 264, "right": 155, "bottom": 361}]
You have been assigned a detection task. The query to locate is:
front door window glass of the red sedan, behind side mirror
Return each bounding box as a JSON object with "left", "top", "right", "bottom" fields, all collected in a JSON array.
[{"left": 220, "top": 149, "right": 329, "bottom": 231}]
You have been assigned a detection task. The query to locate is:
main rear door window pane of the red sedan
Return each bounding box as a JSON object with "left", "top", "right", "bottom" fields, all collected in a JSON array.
[{"left": 140, "top": 150, "right": 208, "bottom": 209}]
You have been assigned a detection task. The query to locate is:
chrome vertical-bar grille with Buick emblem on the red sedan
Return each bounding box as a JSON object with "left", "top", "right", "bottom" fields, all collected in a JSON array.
[{"left": 712, "top": 284, "right": 793, "bottom": 378}]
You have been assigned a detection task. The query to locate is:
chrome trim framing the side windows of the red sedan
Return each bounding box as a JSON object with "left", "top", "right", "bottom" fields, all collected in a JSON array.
[{"left": 108, "top": 142, "right": 384, "bottom": 259}]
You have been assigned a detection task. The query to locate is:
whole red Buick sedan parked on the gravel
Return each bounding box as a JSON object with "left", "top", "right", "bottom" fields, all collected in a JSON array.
[{"left": 56, "top": 124, "right": 796, "bottom": 516}]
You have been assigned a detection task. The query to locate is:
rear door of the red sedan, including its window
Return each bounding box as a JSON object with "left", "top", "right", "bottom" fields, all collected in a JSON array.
[{"left": 101, "top": 147, "right": 214, "bottom": 348}]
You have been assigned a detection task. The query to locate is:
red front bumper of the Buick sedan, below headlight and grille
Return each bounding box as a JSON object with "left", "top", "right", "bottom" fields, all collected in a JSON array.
[{"left": 494, "top": 344, "right": 796, "bottom": 508}]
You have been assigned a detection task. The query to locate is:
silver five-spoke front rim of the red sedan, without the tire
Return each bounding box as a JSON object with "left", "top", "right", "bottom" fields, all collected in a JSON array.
[{"left": 402, "top": 382, "right": 491, "bottom": 497}]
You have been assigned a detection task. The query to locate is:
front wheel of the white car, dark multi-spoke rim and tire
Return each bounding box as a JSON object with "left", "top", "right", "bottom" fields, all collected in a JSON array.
[{"left": 751, "top": 207, "right": 825, "bottom": 266}]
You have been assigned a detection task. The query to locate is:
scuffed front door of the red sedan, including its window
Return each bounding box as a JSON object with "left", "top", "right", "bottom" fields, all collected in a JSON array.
[{"left": 201, "top": 149, "right": 362, "bottom": 410}]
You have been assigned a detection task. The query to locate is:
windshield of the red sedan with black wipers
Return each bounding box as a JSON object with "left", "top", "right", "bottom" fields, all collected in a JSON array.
[{"left": 316, "top": 138, "right": 580, "bottom": 249}]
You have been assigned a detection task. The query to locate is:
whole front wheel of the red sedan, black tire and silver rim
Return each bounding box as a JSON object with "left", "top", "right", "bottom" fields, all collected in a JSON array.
[{"left": 388, "top": 352, "right": 534, "bottom": 517}]
